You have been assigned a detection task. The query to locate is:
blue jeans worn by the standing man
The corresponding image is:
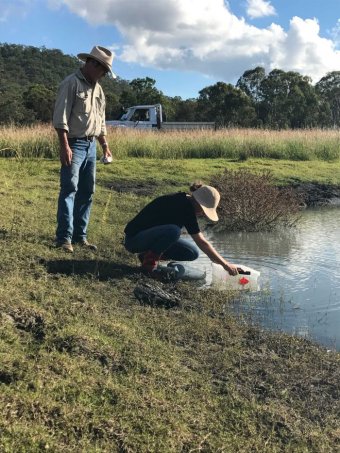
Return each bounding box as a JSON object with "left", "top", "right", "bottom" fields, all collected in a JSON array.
[{"left": 56, "top": 139, "right": 96, "bottom": 242}]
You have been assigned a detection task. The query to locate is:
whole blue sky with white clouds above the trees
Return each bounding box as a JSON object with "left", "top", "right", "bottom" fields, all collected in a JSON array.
[{"left": 0, "top": 0, "right": 340, "bottom": 99}]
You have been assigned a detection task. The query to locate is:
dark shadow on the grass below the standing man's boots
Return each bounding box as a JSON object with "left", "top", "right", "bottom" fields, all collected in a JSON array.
[{"left": 43, "top": 259, "right": 140, "bottom": 280}]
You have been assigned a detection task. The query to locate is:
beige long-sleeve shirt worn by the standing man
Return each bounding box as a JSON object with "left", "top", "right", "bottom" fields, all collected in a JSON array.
[{"left": 53, "top": 69, "right": 106, "bottom": 138}]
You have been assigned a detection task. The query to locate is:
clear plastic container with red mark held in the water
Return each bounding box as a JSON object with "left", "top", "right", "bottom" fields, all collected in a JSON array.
[{"left": 211, "top": 263, "right": 260, "bottom": 291}]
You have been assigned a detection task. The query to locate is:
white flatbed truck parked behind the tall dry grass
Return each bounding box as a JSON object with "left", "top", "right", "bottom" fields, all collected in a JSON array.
[{"left": 106, "top": 104, "right": 216, "bottom": 130}]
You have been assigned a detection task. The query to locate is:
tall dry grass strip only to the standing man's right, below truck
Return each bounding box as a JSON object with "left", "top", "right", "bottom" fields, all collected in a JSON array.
[{"left": 108, "top": 129, "right": 340, "bottom": 161}]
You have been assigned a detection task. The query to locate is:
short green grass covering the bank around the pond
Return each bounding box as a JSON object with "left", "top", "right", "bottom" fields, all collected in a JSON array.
[{"left": 0, "top": 158, "right": 340, "bottom": 453}]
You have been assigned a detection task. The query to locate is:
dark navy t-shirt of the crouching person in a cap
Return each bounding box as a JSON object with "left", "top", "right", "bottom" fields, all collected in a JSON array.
[{"left": 124, "top": 192, "right": 200, "bottom": 236}]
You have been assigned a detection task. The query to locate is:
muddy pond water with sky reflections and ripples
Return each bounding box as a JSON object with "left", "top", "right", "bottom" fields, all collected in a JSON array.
[{"left": 191, "top": 208, "right": 340, "bottom": 350}]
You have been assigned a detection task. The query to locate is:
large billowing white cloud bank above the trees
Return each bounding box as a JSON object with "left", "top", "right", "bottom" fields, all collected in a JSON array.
[{"left": 53, "top": 0, "right": 340, "bottom": 82}]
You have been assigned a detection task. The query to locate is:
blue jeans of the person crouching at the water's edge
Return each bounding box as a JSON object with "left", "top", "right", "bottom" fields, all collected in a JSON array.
[{"left": 124, "top": 225, "right": 199, "bottom": 261}]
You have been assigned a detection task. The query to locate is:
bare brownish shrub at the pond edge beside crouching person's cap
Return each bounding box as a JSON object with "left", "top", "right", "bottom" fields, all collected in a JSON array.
[{"left": 211, "top": 169, "right": 301, "bottom": 231}]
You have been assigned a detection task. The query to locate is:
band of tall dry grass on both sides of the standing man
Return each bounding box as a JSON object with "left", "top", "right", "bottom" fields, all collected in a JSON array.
[{"left": 0, "top": 125, "right": 340, "bottom": 161}]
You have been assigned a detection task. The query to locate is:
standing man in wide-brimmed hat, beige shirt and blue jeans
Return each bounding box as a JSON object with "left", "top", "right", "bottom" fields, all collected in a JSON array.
[{"left": 53, "top": 46, "right": 116, "bottom": 253}]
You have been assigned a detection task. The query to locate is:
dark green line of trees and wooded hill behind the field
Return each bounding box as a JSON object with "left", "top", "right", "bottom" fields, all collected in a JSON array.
[{"left": 0, "top": 43, "right": 340, "bottom": 129}]
